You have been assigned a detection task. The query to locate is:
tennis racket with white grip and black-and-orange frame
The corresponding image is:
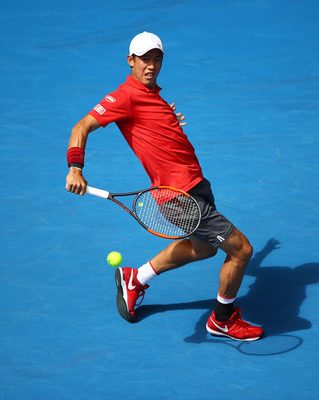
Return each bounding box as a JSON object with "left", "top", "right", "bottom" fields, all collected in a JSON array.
[{"left": 86, "top": 186, "right": 201, "bottom": 239}]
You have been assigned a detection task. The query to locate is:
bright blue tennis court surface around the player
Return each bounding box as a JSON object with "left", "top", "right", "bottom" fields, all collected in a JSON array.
[{"left": 0, "top": 0, "right": 319, "bottom": 400}]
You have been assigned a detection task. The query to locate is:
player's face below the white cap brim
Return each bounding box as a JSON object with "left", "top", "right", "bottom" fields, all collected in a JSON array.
[{"left": 127, "top": 49, "right": 163, "bottom": 89}]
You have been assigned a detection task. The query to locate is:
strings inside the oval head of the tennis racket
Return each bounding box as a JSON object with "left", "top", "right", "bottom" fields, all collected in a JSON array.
[{"left": 135, "top": 188, "right": 200, "bottom": 237}]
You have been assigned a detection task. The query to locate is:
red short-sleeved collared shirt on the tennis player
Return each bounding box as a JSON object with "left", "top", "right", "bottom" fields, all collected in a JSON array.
[{"left": 89, "top": 75, "right": 203, "bottom": 191}]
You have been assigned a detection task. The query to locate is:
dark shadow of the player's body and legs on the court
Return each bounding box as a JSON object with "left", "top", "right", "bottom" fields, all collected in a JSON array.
[{"left": 136, "top": 239, "right": 319, "bottom": 343}]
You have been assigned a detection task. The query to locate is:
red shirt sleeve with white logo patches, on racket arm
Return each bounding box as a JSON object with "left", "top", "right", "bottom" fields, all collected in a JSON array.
[{"left": 89, "top": 87, "right": 132, "bottom": 127}]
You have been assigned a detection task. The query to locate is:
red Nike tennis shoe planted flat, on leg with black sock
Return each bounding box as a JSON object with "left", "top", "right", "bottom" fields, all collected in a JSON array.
[{"left": 206, "top": 307, "right": 263, "bottom": 341}]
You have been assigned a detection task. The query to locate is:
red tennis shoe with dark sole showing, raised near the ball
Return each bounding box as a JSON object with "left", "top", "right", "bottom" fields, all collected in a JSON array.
[{"left": 115, "top": 268, "right": 149, "bottom": 322}]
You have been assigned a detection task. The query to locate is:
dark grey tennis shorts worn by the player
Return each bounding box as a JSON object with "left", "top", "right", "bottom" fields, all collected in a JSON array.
[{"left": 188, "top": 179, "right": 234, "bottom": 248}]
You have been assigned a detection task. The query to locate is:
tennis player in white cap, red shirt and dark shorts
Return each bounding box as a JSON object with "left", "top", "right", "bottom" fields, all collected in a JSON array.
[{"left": 66, "top": 32, "right": 263, "bottom": 341}]
